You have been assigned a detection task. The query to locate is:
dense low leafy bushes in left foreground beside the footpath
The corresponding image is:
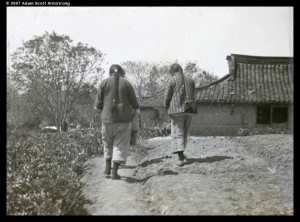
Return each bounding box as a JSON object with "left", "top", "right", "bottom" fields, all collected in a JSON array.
[{"left": 7, "top": 129, "right": 103, "bottom": 215}]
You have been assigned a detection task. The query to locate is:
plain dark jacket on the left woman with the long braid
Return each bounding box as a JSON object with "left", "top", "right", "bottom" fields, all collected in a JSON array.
[{"left": 95, "top": 77, "right": 139, "bottom": 123}]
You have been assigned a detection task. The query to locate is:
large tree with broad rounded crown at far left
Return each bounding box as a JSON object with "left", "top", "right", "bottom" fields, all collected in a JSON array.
[{"left": 11, "top": 32, "right": 104, "bottom": 129}]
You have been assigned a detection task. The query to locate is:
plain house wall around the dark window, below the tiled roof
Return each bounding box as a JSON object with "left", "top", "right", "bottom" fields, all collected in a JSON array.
[{"left": 190, "top": 105, "right": 293, "bottom": 136}]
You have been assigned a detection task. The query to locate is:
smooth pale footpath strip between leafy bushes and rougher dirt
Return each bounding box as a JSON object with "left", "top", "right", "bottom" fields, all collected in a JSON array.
[{"left": 82, "top": 157, "right": 150, "bottom": 215}]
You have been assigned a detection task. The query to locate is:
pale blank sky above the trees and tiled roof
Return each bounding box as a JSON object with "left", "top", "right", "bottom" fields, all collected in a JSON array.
[{"left": 7, "top": 6, "right": 294, "bottom": 78}]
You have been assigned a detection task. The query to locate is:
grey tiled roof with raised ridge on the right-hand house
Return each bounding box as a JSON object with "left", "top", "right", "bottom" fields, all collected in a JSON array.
[{"left": 196, "top": 54, "right": 294, "bottom": 103}]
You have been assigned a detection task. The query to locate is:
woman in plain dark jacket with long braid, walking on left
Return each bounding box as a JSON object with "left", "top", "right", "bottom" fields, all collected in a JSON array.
[{"left": 95, "top": 65, "right": 139, "bottom": 179}]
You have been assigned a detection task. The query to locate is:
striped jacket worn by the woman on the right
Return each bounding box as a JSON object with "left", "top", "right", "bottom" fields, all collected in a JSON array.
[{"left": 164, "top": 73, "right": 197, "bottom": 114}]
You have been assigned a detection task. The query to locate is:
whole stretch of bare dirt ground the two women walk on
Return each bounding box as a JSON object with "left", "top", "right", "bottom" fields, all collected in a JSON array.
[{"left": 83, "top": 135, "right": 293, "bottom": 215}]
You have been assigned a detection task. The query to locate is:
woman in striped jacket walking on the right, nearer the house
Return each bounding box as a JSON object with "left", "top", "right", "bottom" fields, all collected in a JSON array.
[{"left": 164, "top": 63, "right": 197, "bottom": 166}]
